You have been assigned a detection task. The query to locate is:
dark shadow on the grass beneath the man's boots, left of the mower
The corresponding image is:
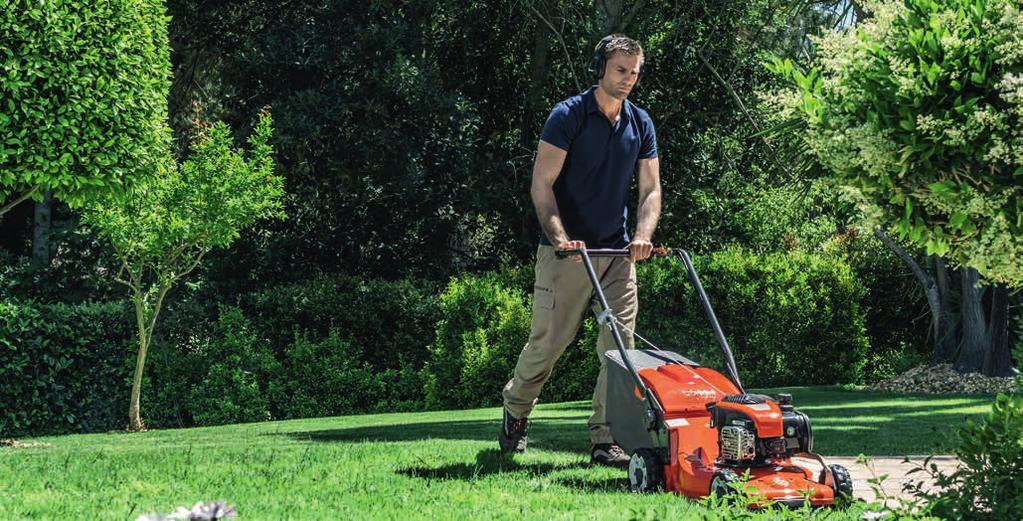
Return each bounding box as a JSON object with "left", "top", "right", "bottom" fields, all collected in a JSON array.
[{"left": 396, "top": 448, "right": 629, "bottom": 492}]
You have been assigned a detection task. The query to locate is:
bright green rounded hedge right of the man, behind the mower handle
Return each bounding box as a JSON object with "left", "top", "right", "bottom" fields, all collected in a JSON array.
[{"left": 638, "top": 249, "right": 869, "bottom": 387}]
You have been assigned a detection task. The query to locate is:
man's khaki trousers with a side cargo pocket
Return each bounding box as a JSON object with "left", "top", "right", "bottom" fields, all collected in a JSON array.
[{"left": 503, "top": 246, "right": 638, "bottom": 444}]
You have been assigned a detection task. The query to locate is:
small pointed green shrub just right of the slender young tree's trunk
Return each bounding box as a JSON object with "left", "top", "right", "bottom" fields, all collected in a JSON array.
[{"left": 188, "top": 306, "right": 277, "bottom": 425}]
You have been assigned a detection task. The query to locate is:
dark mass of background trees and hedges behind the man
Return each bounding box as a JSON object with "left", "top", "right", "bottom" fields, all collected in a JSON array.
[{"left": 0, "top": 0, "right": 1023, "bottom": 435}]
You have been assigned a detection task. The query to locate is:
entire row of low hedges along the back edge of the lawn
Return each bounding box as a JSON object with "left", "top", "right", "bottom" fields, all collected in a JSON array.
[{"left": 0, "top": 250, "right": 871, "bottom": 436}]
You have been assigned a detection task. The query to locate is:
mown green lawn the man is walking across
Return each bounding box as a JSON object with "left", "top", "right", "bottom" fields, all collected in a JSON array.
[{"left": 0, "top": 388, "right": 991, "bottom": 520}]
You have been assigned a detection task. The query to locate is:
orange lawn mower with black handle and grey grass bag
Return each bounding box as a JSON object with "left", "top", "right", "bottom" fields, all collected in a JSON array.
[{"left": 558, "top": 248, "right": 852, "bottom": 507}]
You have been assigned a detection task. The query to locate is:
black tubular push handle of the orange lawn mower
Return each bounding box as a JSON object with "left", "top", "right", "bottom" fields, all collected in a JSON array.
[{"left": 554, "top": 247, "right": 746, "bottom": 395}]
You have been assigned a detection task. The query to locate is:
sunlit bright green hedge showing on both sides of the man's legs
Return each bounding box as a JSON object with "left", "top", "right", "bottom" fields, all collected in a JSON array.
[{"left": 424, "top": 249, "right": 869, "bottom": 408}]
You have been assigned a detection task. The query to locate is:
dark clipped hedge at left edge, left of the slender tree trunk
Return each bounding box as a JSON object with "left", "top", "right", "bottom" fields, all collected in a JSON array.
[{"left": 0, "top": 301, "right": 132, "bottom": 437}]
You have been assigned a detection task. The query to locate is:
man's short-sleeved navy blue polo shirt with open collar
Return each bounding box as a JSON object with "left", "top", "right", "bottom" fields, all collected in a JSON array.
[{"left": 540, "top": 87, "right": 657, "bottom": 248}]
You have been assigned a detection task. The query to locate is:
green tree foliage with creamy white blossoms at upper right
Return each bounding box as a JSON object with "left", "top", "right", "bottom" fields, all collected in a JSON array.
[{"left": 772, "top": 0, "right": 1023, "bottom": 285}]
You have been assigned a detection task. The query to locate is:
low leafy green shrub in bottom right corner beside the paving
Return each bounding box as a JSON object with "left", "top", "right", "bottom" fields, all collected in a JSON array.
[{"left": 913, "top": 394, "right": 1023, "bottom": 519}]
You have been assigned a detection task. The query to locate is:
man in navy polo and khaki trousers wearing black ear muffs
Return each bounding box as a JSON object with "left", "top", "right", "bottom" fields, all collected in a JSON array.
[{"left": 498, "top": 35, "right": 661, "bottom": 467}]
